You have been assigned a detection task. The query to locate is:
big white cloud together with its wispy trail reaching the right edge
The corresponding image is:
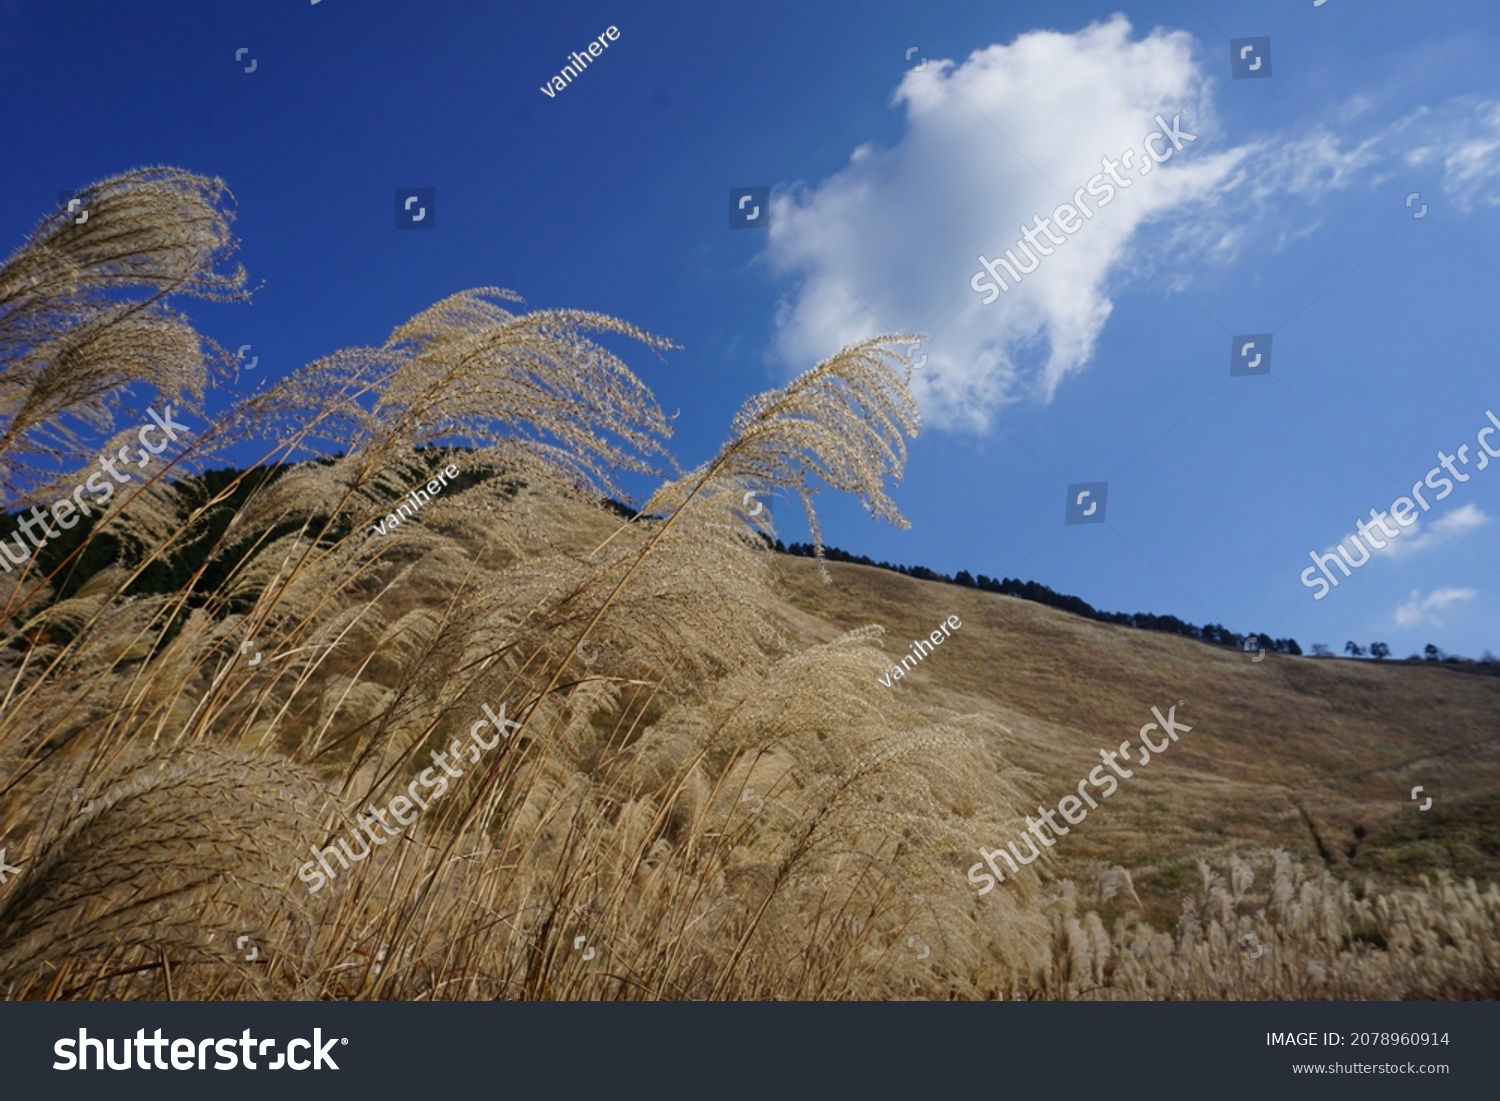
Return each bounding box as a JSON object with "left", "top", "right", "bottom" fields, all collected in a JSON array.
[{"left": 767, "top": 15, "right": 1500, "bottom": 435}]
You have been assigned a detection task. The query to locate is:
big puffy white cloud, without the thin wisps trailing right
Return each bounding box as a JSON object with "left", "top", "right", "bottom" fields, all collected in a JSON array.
[{"left": 768, "top": 17, "right": 1248, "bottom": 429}]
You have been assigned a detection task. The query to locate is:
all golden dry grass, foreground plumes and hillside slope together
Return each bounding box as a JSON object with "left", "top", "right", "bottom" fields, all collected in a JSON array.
[{"left": 0, "top": 170, "right": 1496, "bottom": 999}]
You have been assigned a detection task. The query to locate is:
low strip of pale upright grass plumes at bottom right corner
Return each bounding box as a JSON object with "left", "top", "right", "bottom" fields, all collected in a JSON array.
[{"left": 1029, "top": 851, "right": 1500, "bottom": 1001}]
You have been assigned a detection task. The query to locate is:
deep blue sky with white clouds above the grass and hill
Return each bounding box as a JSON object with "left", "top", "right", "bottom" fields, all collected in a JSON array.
[{"left": 0, "top": 0, "right": 1500, "bottom": 656}]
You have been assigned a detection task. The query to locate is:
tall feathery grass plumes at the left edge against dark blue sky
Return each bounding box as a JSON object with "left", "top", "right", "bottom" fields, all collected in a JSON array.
[{"left": 0, "top": 168, "right": 249, "bottom": 500}]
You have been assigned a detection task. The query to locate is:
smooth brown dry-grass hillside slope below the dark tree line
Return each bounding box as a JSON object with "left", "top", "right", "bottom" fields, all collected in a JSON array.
[{"left": 777, "top": 558, "right": 1500, "bottom": 920}]
